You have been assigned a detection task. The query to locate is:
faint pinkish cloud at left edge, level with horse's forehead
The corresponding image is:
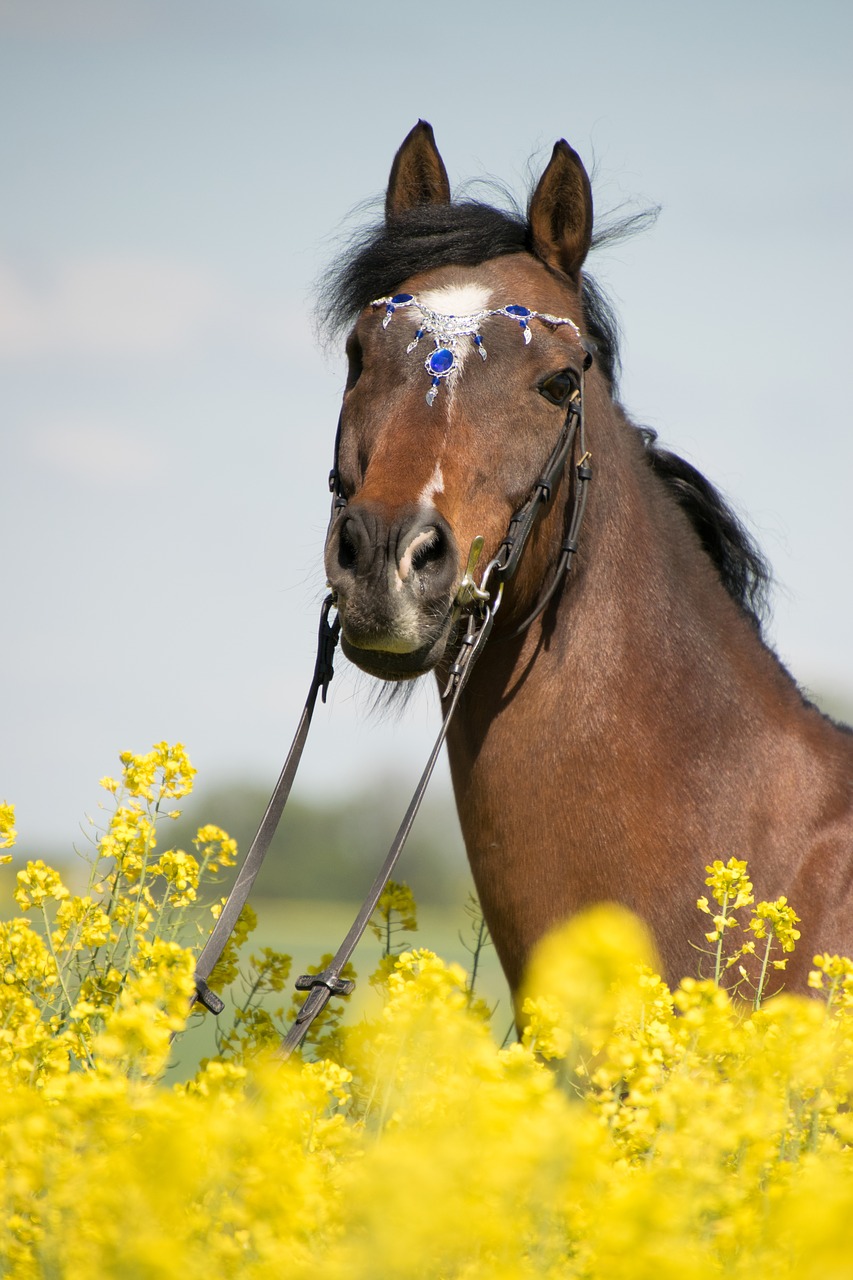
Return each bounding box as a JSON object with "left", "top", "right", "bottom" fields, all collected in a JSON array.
[{"left": 0, "top": 255, "right": 228, "bottom": 360}]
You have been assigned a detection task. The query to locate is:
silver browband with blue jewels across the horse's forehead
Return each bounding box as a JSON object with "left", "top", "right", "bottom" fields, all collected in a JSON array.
[{"left": 370, "top": 293, "right": 580, "bottom": 406}]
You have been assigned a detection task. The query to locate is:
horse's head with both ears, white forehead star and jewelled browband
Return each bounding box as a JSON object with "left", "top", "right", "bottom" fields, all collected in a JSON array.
[{"left": 325, "top": 122, "right": 593, "bottom": 681}]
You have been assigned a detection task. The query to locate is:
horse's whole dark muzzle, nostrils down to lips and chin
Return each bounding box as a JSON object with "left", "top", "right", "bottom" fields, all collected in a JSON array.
[{"left": 325, "top": 499, "right": 459, "bottom": 680}]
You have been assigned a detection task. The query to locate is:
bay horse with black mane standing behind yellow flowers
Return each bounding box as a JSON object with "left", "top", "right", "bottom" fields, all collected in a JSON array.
[{"left": 321, "top": 120, "right": 853, "bottom": 993}]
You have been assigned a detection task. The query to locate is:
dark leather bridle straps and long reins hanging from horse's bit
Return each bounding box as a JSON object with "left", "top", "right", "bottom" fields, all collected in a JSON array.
[{"left": 191, "top": 352, "right": 592, "bottom": 1059}]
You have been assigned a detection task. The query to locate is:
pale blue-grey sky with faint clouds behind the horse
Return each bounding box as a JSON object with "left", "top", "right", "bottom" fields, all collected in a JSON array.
[{"left": 0, "top": 0, "right": 853, "bottom": 847}]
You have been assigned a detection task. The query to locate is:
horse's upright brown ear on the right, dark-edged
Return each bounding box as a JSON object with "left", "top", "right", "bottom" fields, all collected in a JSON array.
[{"left": 529, "top": 138, "right": 593, "bottom": 276}]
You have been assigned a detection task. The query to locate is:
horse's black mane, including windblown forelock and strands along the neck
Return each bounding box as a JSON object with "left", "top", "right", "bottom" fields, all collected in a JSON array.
[{"left": 318, "top": 201, "right": 771, "bottom": 630}]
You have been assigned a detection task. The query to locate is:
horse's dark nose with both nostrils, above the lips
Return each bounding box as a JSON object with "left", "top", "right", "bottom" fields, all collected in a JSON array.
[{"left": 327, "top": 503, "right": 457, "bottom": 603}]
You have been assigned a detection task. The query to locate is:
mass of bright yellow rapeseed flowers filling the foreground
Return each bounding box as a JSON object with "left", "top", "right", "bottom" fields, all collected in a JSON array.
[{"left": 0, "top": 744, "right": 853, "bottom": 1280}]
